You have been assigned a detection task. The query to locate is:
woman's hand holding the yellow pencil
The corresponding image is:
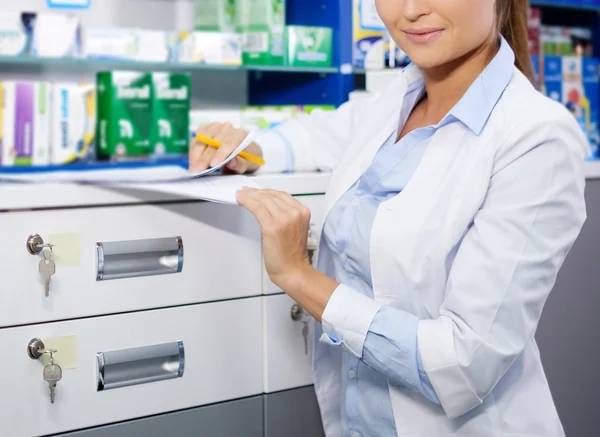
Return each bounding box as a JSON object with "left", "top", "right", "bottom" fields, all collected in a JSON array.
[{"left": 189, "top": 123, "right": 262, "bottom": 174}]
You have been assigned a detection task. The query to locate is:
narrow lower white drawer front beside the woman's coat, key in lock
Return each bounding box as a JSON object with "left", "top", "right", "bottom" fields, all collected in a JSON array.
[{"left": 263, "top": 294, "right": 314, "bottom": 393}]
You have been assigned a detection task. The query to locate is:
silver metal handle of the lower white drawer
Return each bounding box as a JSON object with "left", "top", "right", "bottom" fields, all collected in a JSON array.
[{"left": 96, "top": 341, "right": 185, "bottom": 391}]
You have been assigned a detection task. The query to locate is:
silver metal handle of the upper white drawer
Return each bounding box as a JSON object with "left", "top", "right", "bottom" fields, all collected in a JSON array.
[{"left": 96, "top": 237, "right": 183, "bottom": 281}]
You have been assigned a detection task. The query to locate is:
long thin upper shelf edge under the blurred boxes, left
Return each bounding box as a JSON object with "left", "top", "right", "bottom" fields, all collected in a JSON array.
[{"left": 0, "top": 56, "right": 339, "bottom": 74}]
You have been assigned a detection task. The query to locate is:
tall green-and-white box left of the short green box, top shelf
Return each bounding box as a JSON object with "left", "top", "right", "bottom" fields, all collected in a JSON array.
[{"left": 235, "top": 0, "right": 285, "bottom": 65}]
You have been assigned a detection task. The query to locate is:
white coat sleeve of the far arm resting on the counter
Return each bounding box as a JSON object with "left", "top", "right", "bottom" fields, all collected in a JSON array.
[{"left": 254, "top": 94, "right": 377, "bottom": 173}]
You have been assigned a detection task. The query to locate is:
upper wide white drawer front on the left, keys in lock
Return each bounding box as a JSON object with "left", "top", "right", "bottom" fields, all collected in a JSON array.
[{"left": 0, "top": 202, "right": 263, "bottom": 326}]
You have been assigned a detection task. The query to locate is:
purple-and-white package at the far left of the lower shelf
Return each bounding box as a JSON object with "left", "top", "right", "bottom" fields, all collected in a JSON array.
[{"left": 0, "top": 81, "right": 51, "bottom": 166}]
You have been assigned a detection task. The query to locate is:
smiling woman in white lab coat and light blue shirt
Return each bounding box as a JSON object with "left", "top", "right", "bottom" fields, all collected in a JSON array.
[{"left": 190, "top": 0, "right": 587, "bottom": 437}]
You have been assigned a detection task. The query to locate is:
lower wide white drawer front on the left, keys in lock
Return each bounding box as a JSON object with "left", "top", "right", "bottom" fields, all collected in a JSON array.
[{"left": 0, "top": 297, "right": 263, "bottom": 437}]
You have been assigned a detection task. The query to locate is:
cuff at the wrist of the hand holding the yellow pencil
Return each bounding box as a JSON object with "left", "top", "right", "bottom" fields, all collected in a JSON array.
[{"left": 254, "top": 129, "right": 294, "bottom": 173}]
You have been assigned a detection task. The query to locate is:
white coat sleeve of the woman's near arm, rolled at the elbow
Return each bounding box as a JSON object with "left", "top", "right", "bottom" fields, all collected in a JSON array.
[{"left": 418, "top": 119, "right": 587, "bottom": 418}]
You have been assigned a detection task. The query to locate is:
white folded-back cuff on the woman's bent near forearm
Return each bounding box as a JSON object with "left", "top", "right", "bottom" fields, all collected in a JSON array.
[{"left": 320, "top": 284, "right": 382, "bottom": 359}]
